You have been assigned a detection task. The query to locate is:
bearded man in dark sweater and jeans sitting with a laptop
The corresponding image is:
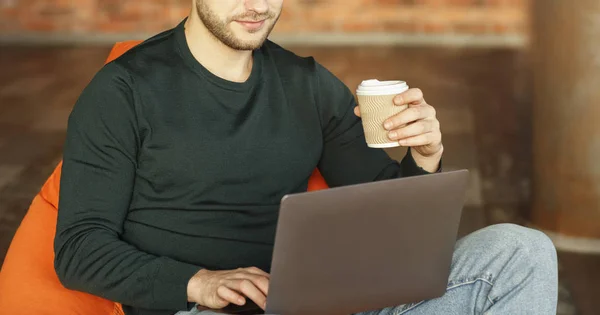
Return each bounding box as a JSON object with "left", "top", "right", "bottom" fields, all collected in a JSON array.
[{"left": 55, "top": 0, "right": 557, "bottom": 315}]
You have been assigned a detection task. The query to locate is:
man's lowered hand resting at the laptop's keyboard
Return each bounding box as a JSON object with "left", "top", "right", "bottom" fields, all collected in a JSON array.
[{"left": 187, "top": 267, "right": 269, "bottom": 310}]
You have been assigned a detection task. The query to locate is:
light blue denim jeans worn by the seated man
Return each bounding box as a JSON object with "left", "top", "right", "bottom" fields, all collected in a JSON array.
[{"left": 177, "top": 224, "right": 558, "bottom": 315}]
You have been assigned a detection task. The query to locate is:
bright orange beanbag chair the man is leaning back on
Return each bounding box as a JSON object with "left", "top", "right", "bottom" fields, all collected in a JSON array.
[{"left": 0, "top": 41, "right": 327, "bottom": 315}]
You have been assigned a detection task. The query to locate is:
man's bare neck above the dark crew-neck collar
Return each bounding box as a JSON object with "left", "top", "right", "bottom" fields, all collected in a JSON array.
[{"left": 184, "top": 10, "right": 253, "bottom": 82}]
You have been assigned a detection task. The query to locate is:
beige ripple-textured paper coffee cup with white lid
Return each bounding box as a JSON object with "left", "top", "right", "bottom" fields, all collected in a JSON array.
[{"left": 356, "top": 80, "right": 408, "bottom": 148}]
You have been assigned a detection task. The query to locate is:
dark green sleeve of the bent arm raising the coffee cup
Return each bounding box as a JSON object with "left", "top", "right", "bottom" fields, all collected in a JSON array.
[{"left": 316, "top": 64, "right": 429, "bottom": 186}]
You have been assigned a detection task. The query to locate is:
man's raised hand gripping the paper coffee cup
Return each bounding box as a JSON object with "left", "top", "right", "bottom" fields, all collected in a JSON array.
[{"left": 354, "top": 89, "right": 444, "bottom": 172}]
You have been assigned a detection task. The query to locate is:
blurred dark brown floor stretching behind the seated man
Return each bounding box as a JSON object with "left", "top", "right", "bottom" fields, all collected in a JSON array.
[{"left": 0, "top": 47, "right": 600, "bottom": 315}]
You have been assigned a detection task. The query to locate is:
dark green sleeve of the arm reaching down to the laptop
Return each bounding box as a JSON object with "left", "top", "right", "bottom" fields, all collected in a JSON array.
[{"left": 54, "top": 63, "right": 200, "bottom": 310}]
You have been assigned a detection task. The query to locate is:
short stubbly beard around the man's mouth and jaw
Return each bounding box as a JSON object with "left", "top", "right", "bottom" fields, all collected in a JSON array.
[{"left": 196, "top": 0, "right": 279, "bottom": 50}]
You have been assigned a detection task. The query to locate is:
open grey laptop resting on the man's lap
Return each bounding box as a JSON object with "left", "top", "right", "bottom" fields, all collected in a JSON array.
[{"left": 216, "top": 170, "right": 469, "bottom": 315}]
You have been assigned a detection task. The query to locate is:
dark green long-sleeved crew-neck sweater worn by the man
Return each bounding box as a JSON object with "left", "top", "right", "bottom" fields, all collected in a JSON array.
[{"left": 55, "top": 22, "right": 426, "bottom": 314}]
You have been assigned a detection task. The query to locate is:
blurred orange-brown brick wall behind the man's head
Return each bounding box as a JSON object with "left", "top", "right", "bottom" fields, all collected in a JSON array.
[{"left": 0, "top": 0, "right": 528, "bottom": 39}]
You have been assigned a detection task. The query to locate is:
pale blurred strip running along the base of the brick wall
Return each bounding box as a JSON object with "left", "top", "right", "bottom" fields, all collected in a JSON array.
[{"left": 0, "top": 33, "right": 528, "bottom": 48}]
